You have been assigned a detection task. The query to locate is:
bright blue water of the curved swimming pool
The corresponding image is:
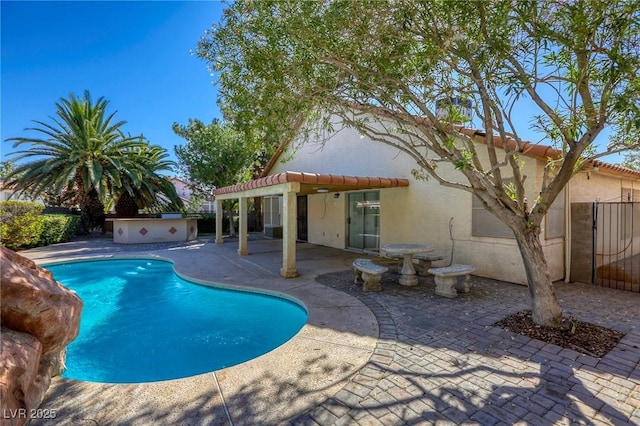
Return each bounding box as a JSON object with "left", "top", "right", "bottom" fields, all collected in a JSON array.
[{"left": 45, "top": 259, "right": 307, "bottom": 383}]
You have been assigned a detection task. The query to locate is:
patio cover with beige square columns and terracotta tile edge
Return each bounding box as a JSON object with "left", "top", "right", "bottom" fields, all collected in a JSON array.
[{"left": 214, "top": 172, "right": 409, "bottom": 278}]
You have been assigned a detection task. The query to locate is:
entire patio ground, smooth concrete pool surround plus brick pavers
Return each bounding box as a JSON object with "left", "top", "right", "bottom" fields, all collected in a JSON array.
[{"left": 22, "top": 238, "right": 640, "bottom": 425}]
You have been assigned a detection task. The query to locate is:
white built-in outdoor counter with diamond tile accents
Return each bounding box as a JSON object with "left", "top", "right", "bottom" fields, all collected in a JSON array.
[{"left": 107, "top": 216, "right": 198, "bottom": 244}]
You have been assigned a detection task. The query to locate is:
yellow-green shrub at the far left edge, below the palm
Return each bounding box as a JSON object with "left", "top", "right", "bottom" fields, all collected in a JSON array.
[{"left": 0, "top": 201, "right": 44, "bottom": 250}]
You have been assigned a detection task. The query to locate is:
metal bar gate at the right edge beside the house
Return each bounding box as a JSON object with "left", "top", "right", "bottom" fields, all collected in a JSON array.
[{"left": 591, "top": 202, "right": 640, "bottom": 292}]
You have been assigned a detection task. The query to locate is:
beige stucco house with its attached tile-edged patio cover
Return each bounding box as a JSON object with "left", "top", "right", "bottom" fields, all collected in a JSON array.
[{"left": 215, "top": 114, "right": 640, "bottom": 284}]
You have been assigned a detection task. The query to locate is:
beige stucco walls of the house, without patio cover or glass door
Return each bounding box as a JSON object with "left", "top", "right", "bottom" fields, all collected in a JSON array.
[{"left": 270, "top": 115, "right": 564, "bottom": 284}]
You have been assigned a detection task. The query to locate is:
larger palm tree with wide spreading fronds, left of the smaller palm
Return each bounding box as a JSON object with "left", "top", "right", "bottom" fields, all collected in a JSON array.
[{"left": 7, "top": 91, "right": 175, "bottom": 233}]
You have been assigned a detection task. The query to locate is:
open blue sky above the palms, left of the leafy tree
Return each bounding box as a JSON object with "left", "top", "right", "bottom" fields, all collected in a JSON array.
[{"left": 0, "top": 0, "right": 224, "bottom": 166}]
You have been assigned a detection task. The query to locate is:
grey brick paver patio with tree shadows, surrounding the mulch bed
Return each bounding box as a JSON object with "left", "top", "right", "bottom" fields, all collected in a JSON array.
[{"left": 302, "top": 272, "right": 640, "bottom": 424}]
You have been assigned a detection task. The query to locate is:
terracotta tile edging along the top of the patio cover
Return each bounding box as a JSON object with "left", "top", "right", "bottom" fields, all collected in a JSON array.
[{"left": 215, "top": 172, "right": 409, "bottom": 195}]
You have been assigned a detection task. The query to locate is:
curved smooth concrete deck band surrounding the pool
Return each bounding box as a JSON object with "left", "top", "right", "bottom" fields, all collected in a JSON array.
[{"left": 32, "top": 244, "right": 379, "bottom": 425}]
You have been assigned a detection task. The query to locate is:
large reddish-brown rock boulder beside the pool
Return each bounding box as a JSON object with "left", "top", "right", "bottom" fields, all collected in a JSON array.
[{"left": 0, "top": 247, "right": 82, "bottom": 425}]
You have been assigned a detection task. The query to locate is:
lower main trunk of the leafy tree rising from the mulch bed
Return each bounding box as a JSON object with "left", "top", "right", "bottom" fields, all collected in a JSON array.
[{"left": 514, "top": 231, "right": 562, "bottom": 327}]
